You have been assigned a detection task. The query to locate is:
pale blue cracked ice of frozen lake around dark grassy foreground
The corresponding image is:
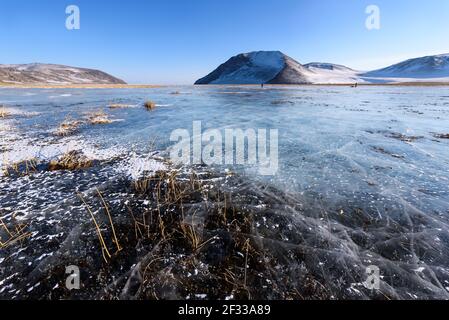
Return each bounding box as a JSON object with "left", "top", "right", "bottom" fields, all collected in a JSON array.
[{"left": 0, "top": 86, "right": 449, "bottom": 299}]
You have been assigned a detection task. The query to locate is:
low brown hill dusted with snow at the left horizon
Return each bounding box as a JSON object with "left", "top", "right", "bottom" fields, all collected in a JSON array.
[{"left": 0, "top": 63, "right": 125, "bottom": 85}]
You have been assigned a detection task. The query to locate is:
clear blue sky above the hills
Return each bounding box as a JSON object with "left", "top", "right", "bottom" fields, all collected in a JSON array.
[{"left": 0, "top": 0, "right": 449, "bottom": 84}]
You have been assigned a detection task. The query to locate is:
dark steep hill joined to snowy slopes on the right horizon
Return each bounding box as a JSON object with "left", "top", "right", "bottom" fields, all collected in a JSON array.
[{"left": 195, "top": 51, "right": 449, "bottom": 85}]
